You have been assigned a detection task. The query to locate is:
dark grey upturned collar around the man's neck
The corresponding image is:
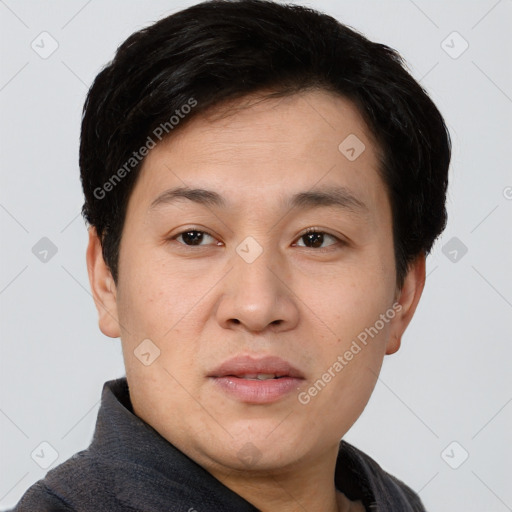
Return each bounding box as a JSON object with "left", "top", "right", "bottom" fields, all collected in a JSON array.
[{"left": 90, "top": 377, "right": 423, "bottom": 512}]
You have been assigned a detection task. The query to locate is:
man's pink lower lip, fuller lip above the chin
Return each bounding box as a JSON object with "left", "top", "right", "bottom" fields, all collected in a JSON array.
[{"left": 213, "top": 376, "right": 303, "bottom": 404}]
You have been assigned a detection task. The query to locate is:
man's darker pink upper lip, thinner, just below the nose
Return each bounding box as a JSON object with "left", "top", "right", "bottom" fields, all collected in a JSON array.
[{"left": 208, "top": 356, "right": 304, "bottom": 379}]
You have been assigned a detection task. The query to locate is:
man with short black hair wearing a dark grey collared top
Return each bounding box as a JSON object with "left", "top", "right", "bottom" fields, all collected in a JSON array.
[{"left": 11, "top": 0, "right": 451, "bottom": 512}]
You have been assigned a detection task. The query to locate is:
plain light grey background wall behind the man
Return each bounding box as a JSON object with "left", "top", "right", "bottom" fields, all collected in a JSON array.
[{"left": 0, "top": 0, "right": 512, "bottom": 512}]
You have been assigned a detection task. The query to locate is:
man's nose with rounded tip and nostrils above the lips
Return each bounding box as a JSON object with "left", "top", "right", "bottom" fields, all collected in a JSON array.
[{"left": 216, "top": 242, "right": 299, "bottom": 333}]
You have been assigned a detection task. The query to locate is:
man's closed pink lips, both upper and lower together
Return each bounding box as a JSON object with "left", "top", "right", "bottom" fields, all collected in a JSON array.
[{"left": 208, "top": 356, "right": 304, "bottom": 404}]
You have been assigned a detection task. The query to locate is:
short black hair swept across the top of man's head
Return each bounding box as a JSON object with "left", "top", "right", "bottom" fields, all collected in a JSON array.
[{"left": 80, "top": 0, "right": 451, "bottom": 288}]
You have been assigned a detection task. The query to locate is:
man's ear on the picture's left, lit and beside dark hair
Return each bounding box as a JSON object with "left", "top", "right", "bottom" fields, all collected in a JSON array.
[{"left": 86, "top": 226, "right": 121, "bottom": 338}]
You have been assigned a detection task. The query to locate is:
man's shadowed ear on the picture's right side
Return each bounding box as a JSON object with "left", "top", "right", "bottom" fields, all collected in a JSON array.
[{"left": 386, "top": 253, "right": 426, "bottom": 355}]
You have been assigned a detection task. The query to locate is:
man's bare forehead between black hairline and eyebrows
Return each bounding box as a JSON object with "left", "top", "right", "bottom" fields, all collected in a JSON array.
[{"left": 127, "top": 91, "right": 383, "bottom": 210}]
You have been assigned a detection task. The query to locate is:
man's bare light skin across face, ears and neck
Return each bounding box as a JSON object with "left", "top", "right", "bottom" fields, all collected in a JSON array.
[{"left": 87, "top": 90, "right": 425, "bottom": 512}]
